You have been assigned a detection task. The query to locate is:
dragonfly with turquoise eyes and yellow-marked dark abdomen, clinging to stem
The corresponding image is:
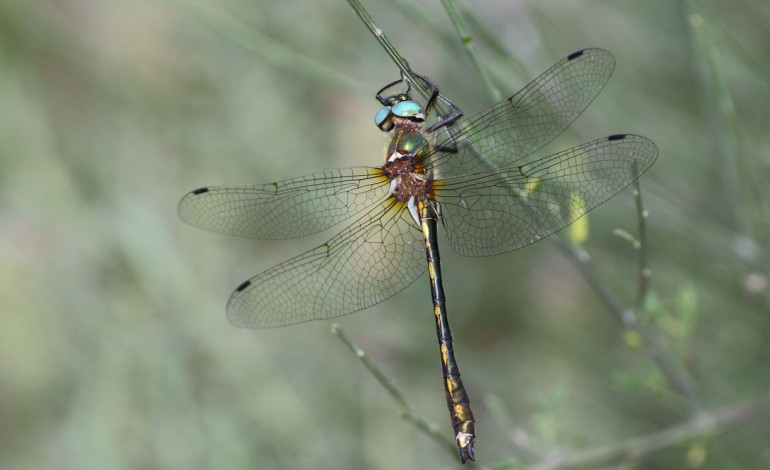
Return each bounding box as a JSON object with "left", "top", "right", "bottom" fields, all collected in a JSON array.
[{"left": 178, "top": 49, "right": 658, "bottom": 463}]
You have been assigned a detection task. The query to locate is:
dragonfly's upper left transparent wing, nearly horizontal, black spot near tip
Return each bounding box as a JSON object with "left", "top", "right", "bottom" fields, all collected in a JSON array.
[{"left": 178, "top": 167, "right": 389, "bottom": 239}]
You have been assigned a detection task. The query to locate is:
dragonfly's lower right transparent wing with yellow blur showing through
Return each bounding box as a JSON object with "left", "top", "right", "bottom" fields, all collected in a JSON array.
[{"left": 434, "top": 134, "right": 658, "bottom": 256}]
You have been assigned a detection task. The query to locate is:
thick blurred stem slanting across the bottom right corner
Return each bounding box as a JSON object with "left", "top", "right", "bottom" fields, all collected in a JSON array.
[{"left": 531, "top": 395, "right": 770, "bottom": 470}]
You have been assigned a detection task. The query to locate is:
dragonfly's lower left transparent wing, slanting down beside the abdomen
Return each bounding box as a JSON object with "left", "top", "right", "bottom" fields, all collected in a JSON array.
[{"left": 227, "top": 199, "right": 427, "bottom": 328}]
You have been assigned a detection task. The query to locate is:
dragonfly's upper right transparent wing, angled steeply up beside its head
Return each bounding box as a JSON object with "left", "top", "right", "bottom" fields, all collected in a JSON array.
[{"left": 428, "top": 49, "right": 615, "bottom": 178}]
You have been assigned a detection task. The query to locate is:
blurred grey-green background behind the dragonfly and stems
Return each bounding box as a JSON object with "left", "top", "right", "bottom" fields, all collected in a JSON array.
[{"left": 0, "top": 0, "right": 770, "bottom": 469}]
